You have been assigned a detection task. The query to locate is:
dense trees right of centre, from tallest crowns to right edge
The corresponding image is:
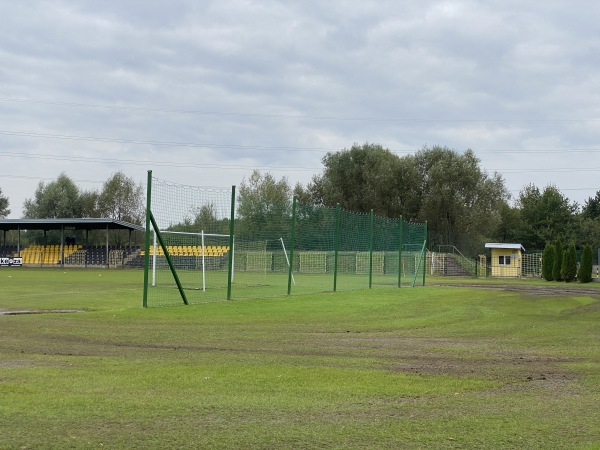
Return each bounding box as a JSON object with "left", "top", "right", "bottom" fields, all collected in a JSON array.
[{"left": 295, "top": 143, "right": 600, "bottom": 256}]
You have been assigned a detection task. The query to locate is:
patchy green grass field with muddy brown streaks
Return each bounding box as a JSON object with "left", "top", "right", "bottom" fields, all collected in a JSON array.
[{"left": 0, "top": 268, "right": 600, "bottom": 449}]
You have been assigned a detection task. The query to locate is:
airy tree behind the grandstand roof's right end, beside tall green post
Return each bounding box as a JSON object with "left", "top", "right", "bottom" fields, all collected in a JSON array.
[{"left": 97, "top": 172, "right": 145, "bottom": 225}]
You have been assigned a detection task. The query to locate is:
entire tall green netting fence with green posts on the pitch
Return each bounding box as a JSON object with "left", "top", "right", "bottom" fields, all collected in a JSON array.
[{"left": 144, "top": 172, "right": 427, "bottom": 306}]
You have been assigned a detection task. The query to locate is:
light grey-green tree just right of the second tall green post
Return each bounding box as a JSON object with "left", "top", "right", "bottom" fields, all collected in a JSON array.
[{"left": 236, "top": 170, "right": 292, "bottom": 240}]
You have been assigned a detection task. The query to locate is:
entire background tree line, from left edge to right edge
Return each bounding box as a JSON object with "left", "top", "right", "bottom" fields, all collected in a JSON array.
[{"left": 0, "top": 143, "right": 600, "bottom": 256}]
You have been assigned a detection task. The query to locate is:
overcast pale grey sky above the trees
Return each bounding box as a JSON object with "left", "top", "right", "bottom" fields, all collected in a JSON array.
[{"left": 0, "top": 0, "right": 600, "bottom": 218}]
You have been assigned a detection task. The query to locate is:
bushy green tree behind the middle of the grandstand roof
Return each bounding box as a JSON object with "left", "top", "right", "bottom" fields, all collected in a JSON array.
[{"left": 23, "top": 173, "right": 84, "bottom": 219}]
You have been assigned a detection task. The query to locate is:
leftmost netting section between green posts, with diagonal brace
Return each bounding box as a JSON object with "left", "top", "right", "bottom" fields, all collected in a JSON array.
[{"left": 143, "top": 171, "right": 235, "bottom": 307}]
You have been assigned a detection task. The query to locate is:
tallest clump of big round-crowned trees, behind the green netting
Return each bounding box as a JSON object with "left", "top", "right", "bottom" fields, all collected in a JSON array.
[{"left": 308, "top": 143, "right": 509, "bottom": 253}]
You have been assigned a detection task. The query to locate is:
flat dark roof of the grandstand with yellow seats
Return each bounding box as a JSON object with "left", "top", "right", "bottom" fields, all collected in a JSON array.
[{"left": 0, "top": 218, "right": 145, "bottom": 231}]
